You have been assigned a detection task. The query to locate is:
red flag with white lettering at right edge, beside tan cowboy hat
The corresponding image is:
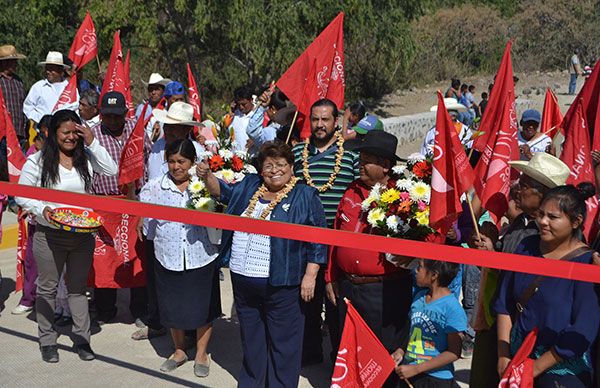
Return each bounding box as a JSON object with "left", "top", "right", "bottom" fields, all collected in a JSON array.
[{"left": 560, "top": 99, "right": 598, "bottom": 241}]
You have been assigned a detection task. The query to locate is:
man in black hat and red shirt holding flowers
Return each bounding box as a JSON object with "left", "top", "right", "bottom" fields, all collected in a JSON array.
[{"left": 325, "top": 131, "right": 412, "bottom": 384}]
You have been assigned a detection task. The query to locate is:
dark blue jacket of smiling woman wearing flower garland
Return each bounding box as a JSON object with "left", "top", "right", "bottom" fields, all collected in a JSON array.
[{"left": 219, "top": 174, "right": 327, "bottom": 286}]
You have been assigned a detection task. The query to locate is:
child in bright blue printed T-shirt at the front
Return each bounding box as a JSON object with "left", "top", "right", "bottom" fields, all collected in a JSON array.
[{"left": 392, "top": 259, "right": 467, "bottom": 388}]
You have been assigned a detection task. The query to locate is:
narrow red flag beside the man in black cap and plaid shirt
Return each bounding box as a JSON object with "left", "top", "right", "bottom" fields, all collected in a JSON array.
[{"left": 118, "top": 102, "right": 148, "bottom": 186}]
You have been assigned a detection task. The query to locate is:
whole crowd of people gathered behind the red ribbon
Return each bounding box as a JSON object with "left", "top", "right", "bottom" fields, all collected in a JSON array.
[{"left": 0, "top": 42, "right": 600, "bottom": 388}]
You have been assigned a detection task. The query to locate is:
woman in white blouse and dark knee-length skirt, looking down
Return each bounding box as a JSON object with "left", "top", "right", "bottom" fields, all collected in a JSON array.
[{"left": 140, "top": 139, "right": 221, "bottom": 377}]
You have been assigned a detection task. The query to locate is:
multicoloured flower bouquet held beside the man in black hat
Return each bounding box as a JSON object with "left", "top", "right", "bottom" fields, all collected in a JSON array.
[{"left": 362, "top": 154, "right": 435, "bottom": 241}]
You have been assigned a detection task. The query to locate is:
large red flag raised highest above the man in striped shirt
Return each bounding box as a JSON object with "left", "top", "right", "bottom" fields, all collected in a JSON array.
[{"left": 277, "top": 12, "right": 346, "bottom": 109}]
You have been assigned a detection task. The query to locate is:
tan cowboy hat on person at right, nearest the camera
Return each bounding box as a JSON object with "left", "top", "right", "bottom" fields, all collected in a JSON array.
[{"left": 508, "top": 152, "right": 571, "bottom": 189}]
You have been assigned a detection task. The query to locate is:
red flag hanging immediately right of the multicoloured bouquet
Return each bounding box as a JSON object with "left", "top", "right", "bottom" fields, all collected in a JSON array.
[{"left": 429, "top": 91, "right": 475, "bottom": 230}]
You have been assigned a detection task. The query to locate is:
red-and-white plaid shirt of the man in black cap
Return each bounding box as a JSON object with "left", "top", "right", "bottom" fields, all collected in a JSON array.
[{"left": 92, "top": 119, "right": 152, "bottom": 195}]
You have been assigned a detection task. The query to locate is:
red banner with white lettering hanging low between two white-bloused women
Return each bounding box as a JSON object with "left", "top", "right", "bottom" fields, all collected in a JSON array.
[{"left": 88, "top": 211, "right": 146, "bottom": 288}]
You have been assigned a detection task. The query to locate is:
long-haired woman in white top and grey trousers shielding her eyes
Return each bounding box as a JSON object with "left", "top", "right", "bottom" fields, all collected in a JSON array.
[{"left": 16, "top": 110, "right": 118, "bottom": 362}]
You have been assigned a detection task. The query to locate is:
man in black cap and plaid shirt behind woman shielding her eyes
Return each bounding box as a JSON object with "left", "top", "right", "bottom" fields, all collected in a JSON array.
[{"left": 92, "top": 92, "right": 152, "bottom": 325}]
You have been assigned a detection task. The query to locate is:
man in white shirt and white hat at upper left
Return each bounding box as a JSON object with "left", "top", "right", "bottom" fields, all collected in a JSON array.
[{"left": 23, "top": 51, "right": 79, "bottom": 124}]
